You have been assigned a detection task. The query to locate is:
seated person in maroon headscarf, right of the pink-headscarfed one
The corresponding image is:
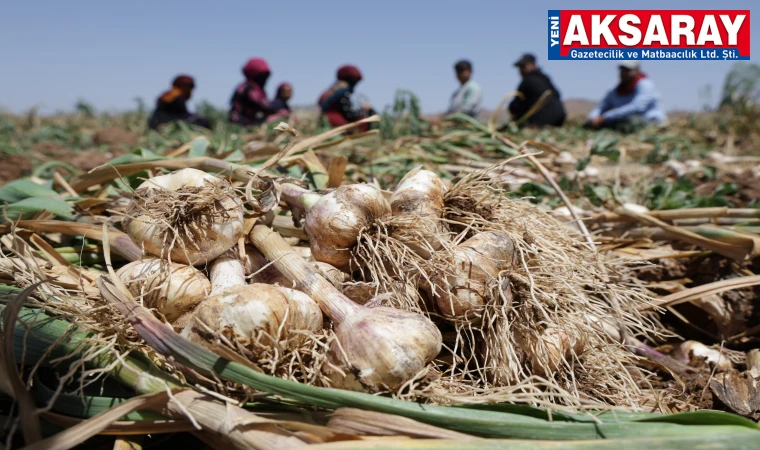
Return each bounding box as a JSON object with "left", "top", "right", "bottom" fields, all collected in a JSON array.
[{"left": 318, "top": 65, "right": 375, "bottom": 129}]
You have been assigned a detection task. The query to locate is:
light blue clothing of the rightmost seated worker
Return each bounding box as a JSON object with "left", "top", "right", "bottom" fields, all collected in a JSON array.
[{"left": 588, "top": 78, "right": 668, "bottom": 124}]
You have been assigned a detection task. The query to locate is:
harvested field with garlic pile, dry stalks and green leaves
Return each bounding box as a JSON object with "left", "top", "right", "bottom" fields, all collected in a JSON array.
[{"left": 0, "top": 64, "right": 760, "bottom": 449}]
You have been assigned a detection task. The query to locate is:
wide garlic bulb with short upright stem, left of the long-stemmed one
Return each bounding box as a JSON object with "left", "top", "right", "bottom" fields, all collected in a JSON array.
[{"left": 182, "top": 254, "right": 323, "bottom": 346}]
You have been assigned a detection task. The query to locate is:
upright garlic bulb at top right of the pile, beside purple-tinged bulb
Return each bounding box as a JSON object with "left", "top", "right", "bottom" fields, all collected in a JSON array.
[{"left": 390, "top": 166, "right": 448, "bottom": 259}]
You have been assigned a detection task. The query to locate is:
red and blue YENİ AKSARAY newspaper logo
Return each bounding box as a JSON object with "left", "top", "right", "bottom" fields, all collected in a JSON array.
[{"left": 549, "top": 9, "right": 750, "bottom": 60}]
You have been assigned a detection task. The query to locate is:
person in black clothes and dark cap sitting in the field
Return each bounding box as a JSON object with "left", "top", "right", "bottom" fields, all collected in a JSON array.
[{"left": 509, "top": 53, "right": 567, "bottom": 127}]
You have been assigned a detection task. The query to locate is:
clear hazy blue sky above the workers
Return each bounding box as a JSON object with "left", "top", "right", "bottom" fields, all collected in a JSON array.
[{"left": 0, "top": 0, "right": 760, "bottom": 113}]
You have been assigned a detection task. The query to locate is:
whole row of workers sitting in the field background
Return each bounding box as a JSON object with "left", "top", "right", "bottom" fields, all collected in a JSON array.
[{"left": 149, "top": 54, "right": 667, "bottom": 129}]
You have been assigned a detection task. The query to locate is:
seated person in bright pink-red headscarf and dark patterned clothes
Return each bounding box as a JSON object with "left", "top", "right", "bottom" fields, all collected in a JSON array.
[{"left": 229, "top": 58, "right": 277, "bottom": 126}]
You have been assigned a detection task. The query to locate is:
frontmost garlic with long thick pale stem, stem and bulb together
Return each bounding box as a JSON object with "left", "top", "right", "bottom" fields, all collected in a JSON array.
[{"left": 249, "top": 225, "right": 442, "bottom": 391}]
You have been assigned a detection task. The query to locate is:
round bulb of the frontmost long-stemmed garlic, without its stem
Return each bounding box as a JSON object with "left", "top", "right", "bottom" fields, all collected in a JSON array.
[{"left": 323, "top": 306, "right": 442, "bottom": 392}]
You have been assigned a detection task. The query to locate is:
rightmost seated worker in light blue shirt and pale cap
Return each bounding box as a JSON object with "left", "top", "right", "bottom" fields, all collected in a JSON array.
[{"left": 585, "top": 61, "right": 667, "bottom": 128}]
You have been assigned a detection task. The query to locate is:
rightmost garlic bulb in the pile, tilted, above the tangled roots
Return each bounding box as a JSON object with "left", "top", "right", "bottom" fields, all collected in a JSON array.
[{"left": 429, "top": 231, "right": 515, "bottom": 323}]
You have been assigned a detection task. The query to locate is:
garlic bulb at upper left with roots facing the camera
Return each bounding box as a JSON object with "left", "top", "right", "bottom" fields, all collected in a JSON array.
[{"left": 124, "top": 168, "right": 243, "bottom": 266}]
